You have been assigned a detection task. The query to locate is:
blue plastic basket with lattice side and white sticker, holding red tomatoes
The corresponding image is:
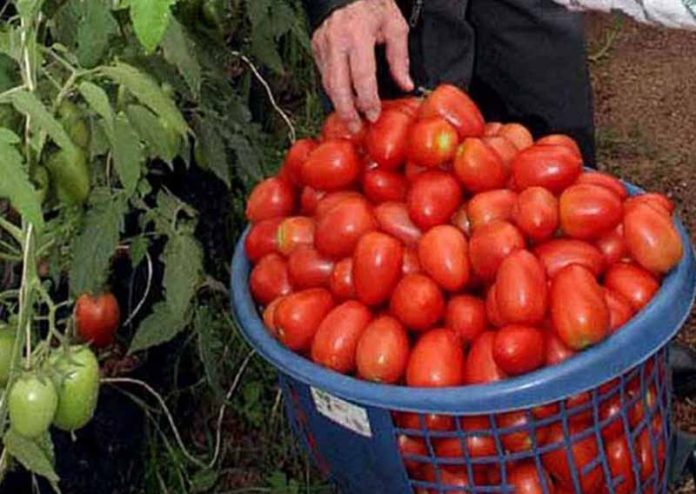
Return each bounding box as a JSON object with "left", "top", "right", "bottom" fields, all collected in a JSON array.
[{"left": 231, "top": 183, "right": 696, "bottom": 494}]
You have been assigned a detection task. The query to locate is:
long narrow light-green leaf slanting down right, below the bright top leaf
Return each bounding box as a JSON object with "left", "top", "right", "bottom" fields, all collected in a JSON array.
[{"left": 102, "top": 62, "right": 189, "bottom": 137}]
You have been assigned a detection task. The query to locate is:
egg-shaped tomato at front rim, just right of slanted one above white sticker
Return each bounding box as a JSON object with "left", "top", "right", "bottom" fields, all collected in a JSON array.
[{"left": 355, "top": 316, "right": 411, "bottom": 384}]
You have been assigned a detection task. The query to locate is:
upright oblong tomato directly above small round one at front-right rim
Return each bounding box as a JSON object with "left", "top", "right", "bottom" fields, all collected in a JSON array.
[{"left": 495, "top": 249, "right": 548, "bottom": 324}]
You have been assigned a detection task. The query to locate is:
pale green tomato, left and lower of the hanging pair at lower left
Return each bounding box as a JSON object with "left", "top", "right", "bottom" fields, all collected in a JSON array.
[{"left": 7, "top": 373, "right": 58, "bottom": 438}]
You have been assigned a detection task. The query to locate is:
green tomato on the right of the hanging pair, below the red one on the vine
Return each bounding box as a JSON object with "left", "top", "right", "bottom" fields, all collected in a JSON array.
[{"left": 49, "top": 346, "right": 99, "bottom": 431}]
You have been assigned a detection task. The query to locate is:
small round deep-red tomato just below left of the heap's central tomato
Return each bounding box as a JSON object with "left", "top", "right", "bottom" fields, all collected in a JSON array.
[{"left": 389, "top": 274, "right": 445, "bottom": 331}]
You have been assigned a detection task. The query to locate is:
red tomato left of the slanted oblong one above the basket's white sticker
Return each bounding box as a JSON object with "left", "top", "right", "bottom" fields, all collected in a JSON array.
[{"left": 273, "top": 288, "right": 334, "bottom": 351}]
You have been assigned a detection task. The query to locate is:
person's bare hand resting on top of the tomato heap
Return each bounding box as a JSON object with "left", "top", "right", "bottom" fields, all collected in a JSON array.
[{"left": 312, "top": 0, "right": 413, "bottom": 132}]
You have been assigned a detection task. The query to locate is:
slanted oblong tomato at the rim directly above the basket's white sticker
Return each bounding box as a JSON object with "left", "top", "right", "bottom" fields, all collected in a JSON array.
[{"left": 312, "top": 300, "right": 372, "bottom": 374}]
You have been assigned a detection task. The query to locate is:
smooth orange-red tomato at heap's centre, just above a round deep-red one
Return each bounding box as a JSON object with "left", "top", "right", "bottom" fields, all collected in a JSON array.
[{"left": 418, "top": 225, "right": 469, "bottom": 292}]
